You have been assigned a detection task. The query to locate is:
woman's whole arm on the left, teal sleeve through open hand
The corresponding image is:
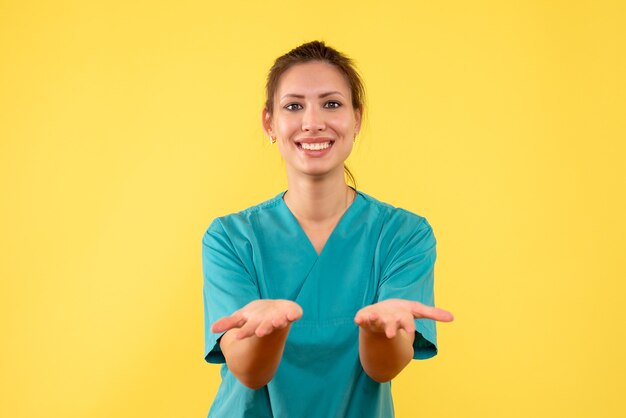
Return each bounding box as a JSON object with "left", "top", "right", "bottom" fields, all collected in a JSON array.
[{"left": 202, "top": 219, "right": 302, "bottom": 389}]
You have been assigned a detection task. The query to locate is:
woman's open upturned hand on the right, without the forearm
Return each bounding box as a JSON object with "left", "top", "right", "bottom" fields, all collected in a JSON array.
[{"left": 354, "top": 299, "right": 454, "bottom": 338}]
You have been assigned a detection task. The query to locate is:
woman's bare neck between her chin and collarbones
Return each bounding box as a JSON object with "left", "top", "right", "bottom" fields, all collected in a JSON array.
[{"left": 284, "top": 171, "right": 355, "bottom": 224}]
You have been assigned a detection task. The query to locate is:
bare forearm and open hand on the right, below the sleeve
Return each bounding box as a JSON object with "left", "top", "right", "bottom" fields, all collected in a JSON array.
[{"left": 354, "top": 299, "right": 454, "bottom": 383}]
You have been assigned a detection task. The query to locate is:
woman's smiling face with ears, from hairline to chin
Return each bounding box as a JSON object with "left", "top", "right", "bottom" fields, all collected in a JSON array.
[{"left": 263, "top": 61, "right": 361, "bottom": 177}]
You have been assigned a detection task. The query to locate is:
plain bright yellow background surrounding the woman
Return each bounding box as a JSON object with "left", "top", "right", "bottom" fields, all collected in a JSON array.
[{"left": 0, "top": 0, "right": 626, "bottom": 418}]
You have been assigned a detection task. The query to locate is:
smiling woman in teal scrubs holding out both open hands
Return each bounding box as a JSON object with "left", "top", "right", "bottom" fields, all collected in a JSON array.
[{"left": 203, "top": 42, "right": 452, "bottom": 418}]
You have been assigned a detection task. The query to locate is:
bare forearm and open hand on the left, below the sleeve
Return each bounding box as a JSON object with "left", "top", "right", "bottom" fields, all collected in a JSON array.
[{"left": 211, "top": 299, "right": 302, "bottom": 390}]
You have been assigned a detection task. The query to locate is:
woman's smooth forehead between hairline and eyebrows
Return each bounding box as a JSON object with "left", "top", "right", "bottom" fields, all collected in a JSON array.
[{"left": 276, "top": 61, "right": 350, "bottom": 98}]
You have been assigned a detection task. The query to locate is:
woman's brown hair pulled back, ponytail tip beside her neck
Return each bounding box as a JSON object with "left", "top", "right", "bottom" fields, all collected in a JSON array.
[{"left": 265, "top": 41, "right": 365, "bottom": 189}]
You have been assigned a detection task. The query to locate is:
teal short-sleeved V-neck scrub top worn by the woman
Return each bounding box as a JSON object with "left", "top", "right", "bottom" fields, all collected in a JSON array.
[{"left": 202, "top": 191, "right": 437, "bottom": 418}]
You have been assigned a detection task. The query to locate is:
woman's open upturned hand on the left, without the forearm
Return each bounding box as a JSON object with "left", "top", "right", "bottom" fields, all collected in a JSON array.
[{"left": 211, "top": 299, "right": 302, "bottom": 340}]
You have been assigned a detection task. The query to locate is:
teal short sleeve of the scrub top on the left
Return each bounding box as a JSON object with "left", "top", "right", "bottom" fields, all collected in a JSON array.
[{"left": 202, "top": 218, "right": 260, "bottom": 363}]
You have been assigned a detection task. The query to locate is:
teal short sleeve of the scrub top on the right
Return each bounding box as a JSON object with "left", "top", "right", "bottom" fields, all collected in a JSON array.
[{"left": 378, "top": 218, "right": 437, "bottom": 359}]
